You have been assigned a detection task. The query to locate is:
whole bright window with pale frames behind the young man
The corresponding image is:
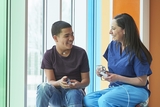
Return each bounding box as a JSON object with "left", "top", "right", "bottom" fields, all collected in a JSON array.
[{"left": 27, "top": 0, "right": 87, "bottom": 107}]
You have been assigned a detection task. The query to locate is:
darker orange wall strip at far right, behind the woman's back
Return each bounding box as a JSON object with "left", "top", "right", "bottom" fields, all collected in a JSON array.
[{"left": 149, "top": 0, "right": 160, "bottom": 107}]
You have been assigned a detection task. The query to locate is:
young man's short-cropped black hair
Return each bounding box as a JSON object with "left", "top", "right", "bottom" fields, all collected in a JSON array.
[{"left": 51, "top": 21, "right": 71, "bottom": 36}]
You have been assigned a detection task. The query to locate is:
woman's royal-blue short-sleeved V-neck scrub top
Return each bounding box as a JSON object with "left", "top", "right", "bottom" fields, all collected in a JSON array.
[{"left": 103, "top": 41, "right": 152, "bottom": 94}]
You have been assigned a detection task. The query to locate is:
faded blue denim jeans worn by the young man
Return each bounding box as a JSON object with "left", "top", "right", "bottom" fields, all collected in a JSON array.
[{"left": 36, "top": 83, "right": 84, "bottom": 107}]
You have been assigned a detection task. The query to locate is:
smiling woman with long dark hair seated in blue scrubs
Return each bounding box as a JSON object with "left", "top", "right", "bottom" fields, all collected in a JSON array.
[{"left": 84, "top": 13, "right": 152, "bottom": 107}]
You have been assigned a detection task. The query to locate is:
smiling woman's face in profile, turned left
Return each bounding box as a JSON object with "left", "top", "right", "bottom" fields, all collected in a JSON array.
[{"left": 109, "top": 19, "right": 125, "bottom": 42}]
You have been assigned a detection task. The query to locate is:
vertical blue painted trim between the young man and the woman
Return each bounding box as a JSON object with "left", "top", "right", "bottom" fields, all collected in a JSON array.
[{"left": 87, "top": 0, "right": 101, "bottom": 93}]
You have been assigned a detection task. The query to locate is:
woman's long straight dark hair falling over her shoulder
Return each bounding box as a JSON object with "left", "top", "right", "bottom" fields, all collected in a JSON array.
[{"left": 114, "top": 13, "right": 152, "bottom": 64}]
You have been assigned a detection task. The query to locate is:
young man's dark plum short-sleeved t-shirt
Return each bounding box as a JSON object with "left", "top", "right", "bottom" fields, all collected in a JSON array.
[{"left": 41, "top": 45, "right": 89, "bottom": 82}]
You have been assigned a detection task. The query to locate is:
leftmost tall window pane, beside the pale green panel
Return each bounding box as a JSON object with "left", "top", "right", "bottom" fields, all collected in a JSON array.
[{"left": 27, "top": 0, "right": 43, "bottom": 107}]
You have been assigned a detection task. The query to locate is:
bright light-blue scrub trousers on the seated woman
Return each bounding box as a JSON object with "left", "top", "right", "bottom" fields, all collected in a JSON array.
[{"left": 84, "top": 85, "right": 148, "bottom": 107}]
